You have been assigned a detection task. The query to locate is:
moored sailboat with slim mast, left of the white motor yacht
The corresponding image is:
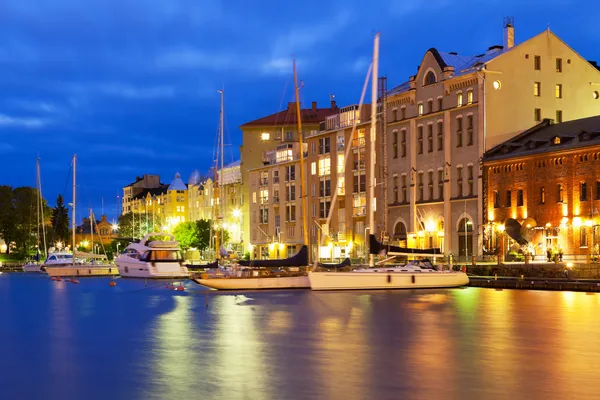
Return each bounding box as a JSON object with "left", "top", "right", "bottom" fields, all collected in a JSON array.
[{"left": 42, "top": 155, "right": 119, "bottom": 277}]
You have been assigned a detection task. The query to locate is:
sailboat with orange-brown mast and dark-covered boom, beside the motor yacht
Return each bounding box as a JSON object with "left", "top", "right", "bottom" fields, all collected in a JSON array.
[{"left": 194, "top": 69, "right": 310, "bottom": 290}]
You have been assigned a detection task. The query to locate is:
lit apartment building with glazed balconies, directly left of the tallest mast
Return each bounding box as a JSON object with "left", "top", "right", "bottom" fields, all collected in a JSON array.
[{"left": 306, "top": 104, "right": 372, "bottom": 260}]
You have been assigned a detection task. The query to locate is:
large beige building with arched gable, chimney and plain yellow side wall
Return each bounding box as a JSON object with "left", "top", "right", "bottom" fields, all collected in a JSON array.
[{"left": 385, "top": 19, "right": 600, "bottom": 258}]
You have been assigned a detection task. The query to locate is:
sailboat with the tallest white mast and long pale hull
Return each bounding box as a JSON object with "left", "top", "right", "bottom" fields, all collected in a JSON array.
[{"left": 308, "top": 33, "right": 469, "bottom": 290}]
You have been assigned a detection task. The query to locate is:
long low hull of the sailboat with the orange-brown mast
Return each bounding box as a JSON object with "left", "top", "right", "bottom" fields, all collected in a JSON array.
[{"left": 194, "top": 275, "right": 310, "bottom": 290}]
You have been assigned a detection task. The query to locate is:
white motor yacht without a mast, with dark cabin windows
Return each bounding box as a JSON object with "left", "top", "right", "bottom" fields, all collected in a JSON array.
[{"left": 115, "top": 233, "right": 190, "bottom": 279}]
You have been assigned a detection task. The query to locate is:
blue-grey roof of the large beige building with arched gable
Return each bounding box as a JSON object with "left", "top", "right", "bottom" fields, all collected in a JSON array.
[{"left": 387, "top": 46, "right": 508, "bottom": 96}]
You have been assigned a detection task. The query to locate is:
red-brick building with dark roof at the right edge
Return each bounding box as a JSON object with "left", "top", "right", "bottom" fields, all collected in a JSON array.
[{"left": 483, "top": 116, "right": 600, "bottom": 260}]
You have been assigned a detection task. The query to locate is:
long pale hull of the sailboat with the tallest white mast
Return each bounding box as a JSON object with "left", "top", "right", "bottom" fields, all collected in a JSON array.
[{"left": 308, "top": 272, "right": 469, "bottom": 290}]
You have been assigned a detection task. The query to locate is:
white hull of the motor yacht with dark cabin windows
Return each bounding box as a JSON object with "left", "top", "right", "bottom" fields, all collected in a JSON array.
[{"left": 115, "top": 256, "right": 190, "bottom": 279}]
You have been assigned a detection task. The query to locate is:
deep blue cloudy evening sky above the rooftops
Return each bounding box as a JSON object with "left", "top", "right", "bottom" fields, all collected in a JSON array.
[{"left": 0, "top": 0, "right": 600, "bottom": 219}]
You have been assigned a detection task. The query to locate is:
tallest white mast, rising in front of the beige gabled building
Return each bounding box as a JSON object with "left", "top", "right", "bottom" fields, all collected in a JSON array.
[{"left": 365, "top": 33, "right": 379, "bottom": 267}]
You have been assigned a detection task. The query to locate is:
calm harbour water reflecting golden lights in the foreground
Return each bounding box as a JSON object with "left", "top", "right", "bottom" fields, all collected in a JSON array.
[{"left": 0, "top": 273, "right": 600, "bottom": 400}]
